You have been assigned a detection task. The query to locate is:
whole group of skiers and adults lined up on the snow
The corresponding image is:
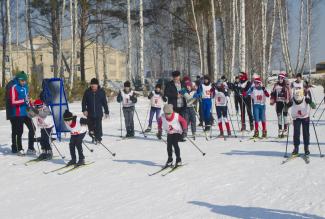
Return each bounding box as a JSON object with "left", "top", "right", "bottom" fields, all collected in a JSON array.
[{"left": 7, "top": 71, "right": 315, "bottom": 169}]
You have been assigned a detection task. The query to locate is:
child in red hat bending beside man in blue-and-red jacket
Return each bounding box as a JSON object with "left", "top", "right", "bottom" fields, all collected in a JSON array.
[{"left": 28, "top": 99, "right": 54, "bottom": 160}]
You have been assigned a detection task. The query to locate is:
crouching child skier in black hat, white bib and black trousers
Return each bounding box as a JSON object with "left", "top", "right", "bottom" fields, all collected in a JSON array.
[{"left": 63, "top": 110, "right": 88, "bottom": 166}]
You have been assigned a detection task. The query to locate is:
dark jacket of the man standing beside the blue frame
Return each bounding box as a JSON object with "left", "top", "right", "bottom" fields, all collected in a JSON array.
[{"left": 82, "top": 87, "right": 109, "bottom": 118}]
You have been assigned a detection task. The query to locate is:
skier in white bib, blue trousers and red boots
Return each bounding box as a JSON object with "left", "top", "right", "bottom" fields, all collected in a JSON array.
[{"left": 247, "top": 77, "right": 270, "bottom": 138}]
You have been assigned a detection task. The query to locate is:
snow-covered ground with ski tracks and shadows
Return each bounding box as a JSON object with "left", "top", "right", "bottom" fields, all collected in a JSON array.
[{"left": 0, "top": 87, "right": 325, "bottom": 219}]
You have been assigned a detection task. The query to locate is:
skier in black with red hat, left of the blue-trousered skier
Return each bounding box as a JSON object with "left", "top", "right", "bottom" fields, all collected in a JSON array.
[{"left": 239, "top": 72, "right": 254, "bottom": 131}]
